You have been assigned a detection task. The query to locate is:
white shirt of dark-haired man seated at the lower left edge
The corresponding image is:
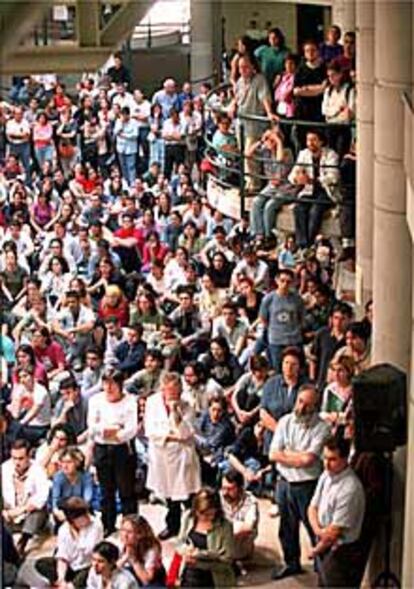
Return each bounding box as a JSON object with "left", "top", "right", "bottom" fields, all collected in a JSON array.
[{"left": 1, "top": 458, "right": 50, "bottom": 509}]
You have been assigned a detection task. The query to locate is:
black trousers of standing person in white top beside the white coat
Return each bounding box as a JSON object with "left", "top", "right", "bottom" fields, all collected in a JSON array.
[{"left": 94, "top": 442, "right": 137, "bottom": 533}]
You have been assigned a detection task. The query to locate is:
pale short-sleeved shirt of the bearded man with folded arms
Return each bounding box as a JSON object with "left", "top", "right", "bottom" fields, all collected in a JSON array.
[{"left": 270, "top": 413, "right": 330, "bottom": 483}]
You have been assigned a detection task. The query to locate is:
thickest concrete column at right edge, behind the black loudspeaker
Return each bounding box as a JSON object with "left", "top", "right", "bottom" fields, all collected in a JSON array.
[{"left": 373, "top": 0, "right": 412, "bottom": 575}]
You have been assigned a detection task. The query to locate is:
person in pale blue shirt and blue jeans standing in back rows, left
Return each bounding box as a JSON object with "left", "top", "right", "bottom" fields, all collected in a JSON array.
[{"left": 114, "top": 106, "right": 139, "bottom": 187}]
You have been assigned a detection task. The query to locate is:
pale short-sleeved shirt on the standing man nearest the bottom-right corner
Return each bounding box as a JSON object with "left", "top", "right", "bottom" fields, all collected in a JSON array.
[{"left": 311, "top": 467, "right": 365, "bottom": 544}]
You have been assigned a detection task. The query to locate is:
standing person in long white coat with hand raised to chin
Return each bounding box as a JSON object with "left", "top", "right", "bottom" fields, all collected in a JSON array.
[{"left": 144, "top": 372, "right": 201, "bottom": 540}]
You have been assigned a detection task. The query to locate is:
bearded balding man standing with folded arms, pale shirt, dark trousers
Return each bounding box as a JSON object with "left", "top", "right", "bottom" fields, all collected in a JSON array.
[{"left": 269, "top": 384, "right": 330, "bottom": 580}]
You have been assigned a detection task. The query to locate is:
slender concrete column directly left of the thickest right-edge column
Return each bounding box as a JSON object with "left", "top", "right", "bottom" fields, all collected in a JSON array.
[{"left": 356, "top": 0, "right": 374, "bottom": 305}]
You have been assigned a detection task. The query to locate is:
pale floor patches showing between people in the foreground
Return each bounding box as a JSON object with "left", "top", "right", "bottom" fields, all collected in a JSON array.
[{"left": 15, "top": 500, "right": 316, "bottom": 589}]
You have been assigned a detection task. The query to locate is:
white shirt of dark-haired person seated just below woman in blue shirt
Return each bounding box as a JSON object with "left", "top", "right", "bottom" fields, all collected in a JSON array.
[{"left": 55, "top": 518, "right": 103, "bottom": 571}]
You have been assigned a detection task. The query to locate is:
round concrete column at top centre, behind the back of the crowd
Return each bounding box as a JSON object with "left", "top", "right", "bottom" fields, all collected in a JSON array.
[{"left": 191, "top": 0, "right": 214, "bottom": 89}]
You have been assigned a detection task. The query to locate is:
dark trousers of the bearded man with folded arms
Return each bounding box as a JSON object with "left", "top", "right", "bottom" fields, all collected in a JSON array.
[{"left": 276, "top": 479, "right": 317, "bottom": 567}]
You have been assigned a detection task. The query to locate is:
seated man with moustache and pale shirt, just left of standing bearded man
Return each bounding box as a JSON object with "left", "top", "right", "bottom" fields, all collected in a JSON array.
[{"left": 220, "top": 470, "right": 259, "bottom": 561}]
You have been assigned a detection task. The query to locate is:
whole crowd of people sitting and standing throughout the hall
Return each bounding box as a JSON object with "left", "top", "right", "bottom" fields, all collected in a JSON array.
[{"left": 0, "top": 27, "right": 381, "bottom": 589}]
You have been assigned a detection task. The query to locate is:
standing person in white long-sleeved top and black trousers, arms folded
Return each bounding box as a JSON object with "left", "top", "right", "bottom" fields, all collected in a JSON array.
[{"left": 88, "top": 369, "right": 138, "bottom": 536}]
